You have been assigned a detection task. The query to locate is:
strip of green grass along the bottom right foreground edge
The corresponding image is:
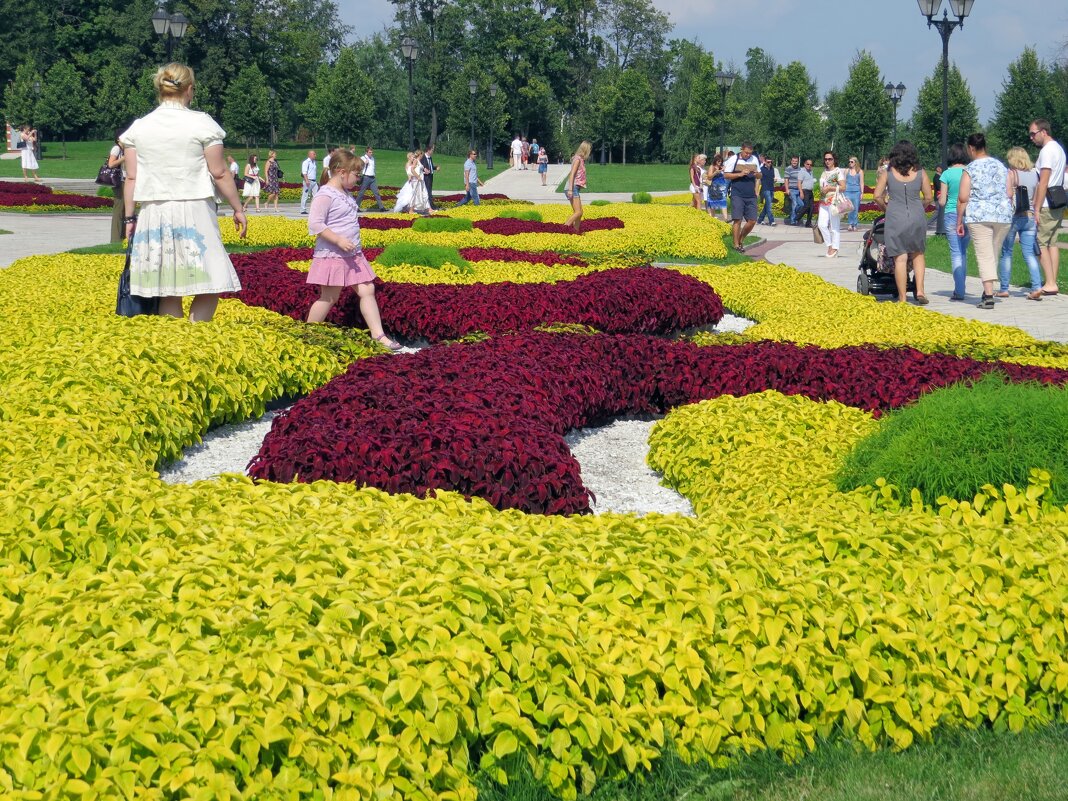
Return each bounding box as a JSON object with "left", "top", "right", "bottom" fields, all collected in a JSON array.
[{"left": 478, "top": 725, "right": 1068, "bottom": 801}]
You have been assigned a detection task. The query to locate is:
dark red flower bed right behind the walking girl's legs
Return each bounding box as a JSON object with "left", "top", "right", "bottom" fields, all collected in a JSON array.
[{"left": 229, "top": 248, "right": 723, "bottom": 342}]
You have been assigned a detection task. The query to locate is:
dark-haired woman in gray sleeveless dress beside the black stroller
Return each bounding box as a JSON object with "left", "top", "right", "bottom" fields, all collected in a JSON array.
[{"left": 875, "top": 140, "right": 933, "bottom": 305}]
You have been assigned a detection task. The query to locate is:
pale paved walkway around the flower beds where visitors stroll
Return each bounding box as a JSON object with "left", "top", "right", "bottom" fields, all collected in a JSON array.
[{"left": 0, "top": 197, "right": 1068, "bottom": 342}]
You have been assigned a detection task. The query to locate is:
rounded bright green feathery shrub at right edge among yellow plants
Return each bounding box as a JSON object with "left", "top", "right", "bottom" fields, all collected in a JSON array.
[{"left": 837, "top": 373, "right": 1068, "bottom": 505}]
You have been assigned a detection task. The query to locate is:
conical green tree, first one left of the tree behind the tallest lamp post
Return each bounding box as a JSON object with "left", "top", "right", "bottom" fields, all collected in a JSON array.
[{"left": 828, "top": 50, "right": 894, "bottom": 168}]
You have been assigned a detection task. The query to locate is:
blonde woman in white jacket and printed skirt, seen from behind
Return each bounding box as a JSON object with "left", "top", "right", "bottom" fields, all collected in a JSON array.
[{"left": 119, "top": 64, "right": 248, "bottom": 323}]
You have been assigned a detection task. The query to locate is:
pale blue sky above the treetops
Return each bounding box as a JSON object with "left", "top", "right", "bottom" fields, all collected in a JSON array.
[{"left": 339, "top": 0, "right": 1068, "bottom": 124}]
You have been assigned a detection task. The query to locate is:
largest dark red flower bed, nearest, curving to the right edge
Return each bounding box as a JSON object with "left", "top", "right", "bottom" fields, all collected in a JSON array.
[{"left": 250, "top": 333, "right": 1068, "bottom": 514}]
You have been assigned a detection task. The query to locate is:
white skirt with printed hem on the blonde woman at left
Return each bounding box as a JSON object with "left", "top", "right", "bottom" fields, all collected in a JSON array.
[{"left": 130, "top": 198, "right": 241, "bottom": 298}]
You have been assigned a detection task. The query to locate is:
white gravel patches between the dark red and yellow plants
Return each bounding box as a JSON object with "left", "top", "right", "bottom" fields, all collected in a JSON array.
[{"left": 159, "top": 314, "right": 753, "bottom": 516}]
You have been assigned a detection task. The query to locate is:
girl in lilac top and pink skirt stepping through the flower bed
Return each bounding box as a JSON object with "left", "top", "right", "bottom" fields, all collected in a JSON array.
[{"left": 308, "top": 150, "right": 401, "bottom": 350}]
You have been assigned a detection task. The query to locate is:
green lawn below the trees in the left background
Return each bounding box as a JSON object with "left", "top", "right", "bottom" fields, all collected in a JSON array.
[{"left": 0, "top": 140, "right": 507, "bottom": 191}]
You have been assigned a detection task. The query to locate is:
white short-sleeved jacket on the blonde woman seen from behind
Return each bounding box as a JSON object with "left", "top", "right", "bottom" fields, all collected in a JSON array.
[{"left": 119, "top": 100, "right": 226, "bottom": 202}]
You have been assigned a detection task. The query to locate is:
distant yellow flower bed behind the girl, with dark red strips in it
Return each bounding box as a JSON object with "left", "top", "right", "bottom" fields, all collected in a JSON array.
[{"left": 220, "top": 203, "right": 728, "bottom": 260}]
